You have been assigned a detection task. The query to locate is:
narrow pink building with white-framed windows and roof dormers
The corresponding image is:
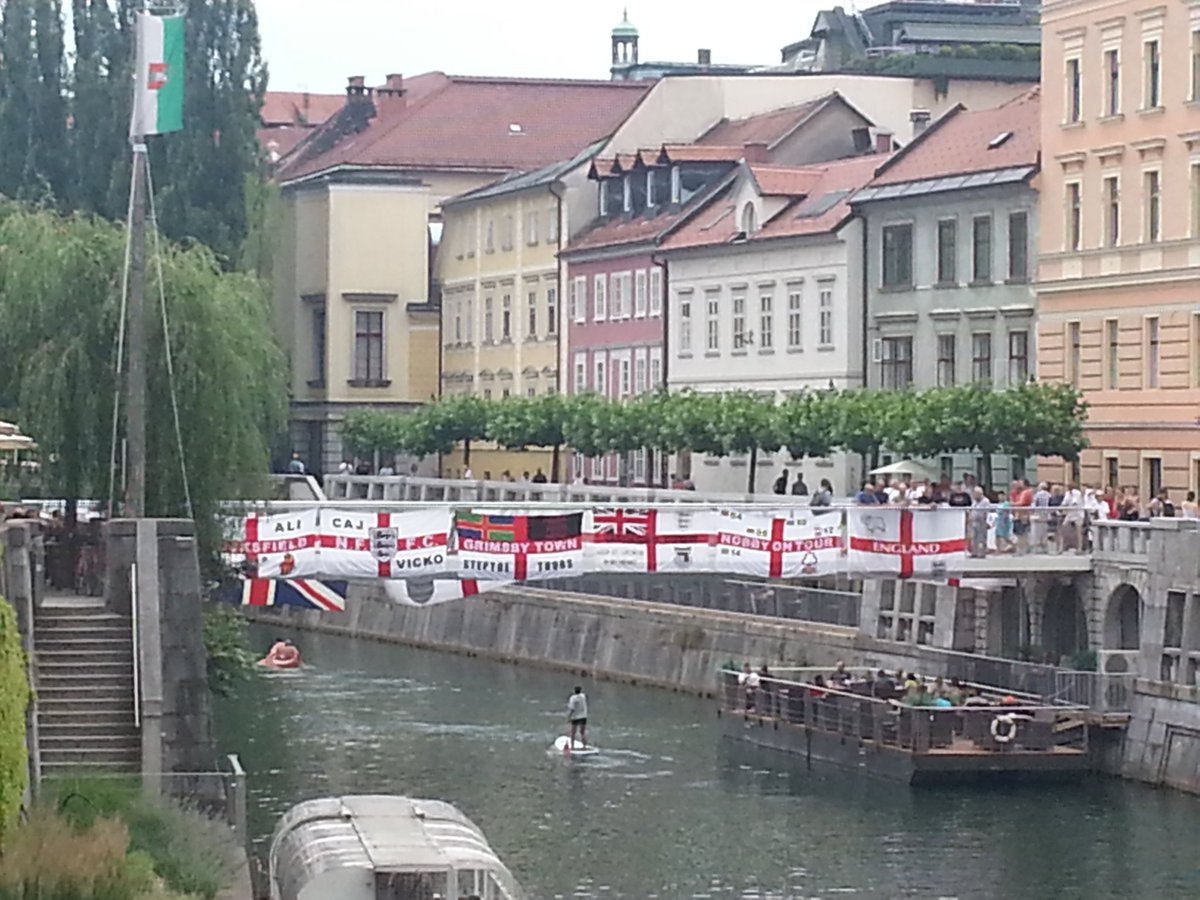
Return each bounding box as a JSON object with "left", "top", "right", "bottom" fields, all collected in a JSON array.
[{"left": 559, "top": 92, "right": 874, "bottom": 485}]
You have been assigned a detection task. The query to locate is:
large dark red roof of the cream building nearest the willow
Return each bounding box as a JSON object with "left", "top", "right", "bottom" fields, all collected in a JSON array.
[{"left": 281, "top": 72, "right": 652, "bottom": 180}]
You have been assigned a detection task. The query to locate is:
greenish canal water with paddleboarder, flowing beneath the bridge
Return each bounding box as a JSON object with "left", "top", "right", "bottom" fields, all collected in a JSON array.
[{"left": 217, "top": 630, "right": 1200, "bottom": 900}]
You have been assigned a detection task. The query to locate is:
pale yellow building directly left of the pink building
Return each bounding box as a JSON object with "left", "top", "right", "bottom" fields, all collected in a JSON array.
[{"left": 436, "top": 148, "right": 602, "bottom": 480}]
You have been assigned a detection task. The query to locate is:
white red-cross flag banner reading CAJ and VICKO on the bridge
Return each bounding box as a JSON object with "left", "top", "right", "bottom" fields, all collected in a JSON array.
[{"left": 320, "top": 506, "right": 451, "bottom": 578}]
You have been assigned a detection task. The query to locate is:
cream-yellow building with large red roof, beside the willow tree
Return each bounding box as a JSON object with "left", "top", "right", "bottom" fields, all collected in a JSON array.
[{"left": 275, "top": 72, "right": 649, "bottom": 472}]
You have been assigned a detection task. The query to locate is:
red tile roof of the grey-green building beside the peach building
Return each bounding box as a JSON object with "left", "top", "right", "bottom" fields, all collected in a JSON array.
[{"left": 871, "top": 88, "right": 1042, "bottom": 187}]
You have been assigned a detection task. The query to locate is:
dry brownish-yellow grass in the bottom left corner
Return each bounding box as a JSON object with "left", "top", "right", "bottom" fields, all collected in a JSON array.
[{"left": 0, "top": 810, "right": 185, "bottom": 900}]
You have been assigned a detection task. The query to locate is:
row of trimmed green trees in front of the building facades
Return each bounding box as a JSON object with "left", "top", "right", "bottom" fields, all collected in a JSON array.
[{"left": 342, "top": 383, "right": 1087, "bottom": 491}]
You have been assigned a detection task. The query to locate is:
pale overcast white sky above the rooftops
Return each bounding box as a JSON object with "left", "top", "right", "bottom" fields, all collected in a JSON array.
[{"left": 257, "top": 0, "right": 830, "bottom": 94}]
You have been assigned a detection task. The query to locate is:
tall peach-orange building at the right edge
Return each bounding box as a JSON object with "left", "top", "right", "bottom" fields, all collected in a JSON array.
[{"left": 1038, "top": 0, "right": 1200, "bottom": 504}]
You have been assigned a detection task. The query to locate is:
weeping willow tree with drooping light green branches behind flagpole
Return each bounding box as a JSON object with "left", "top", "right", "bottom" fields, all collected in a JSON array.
[{"left": 0, "top": 204, "right": 287, "bottom": 554}]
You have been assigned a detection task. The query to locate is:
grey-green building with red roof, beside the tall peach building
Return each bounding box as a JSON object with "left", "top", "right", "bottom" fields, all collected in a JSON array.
[{"left": 853, "top": 89, "right": 1042, "bottom": 485}]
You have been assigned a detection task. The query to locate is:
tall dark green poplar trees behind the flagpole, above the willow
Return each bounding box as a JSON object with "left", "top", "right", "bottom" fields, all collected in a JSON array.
[{"left": 0, "top": 0, "right": 271, "bottom": 267}]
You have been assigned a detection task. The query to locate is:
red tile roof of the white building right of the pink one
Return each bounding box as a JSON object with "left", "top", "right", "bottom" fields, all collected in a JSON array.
[{"left": 662, "top": 155, "right": 888, "bottom": 251}]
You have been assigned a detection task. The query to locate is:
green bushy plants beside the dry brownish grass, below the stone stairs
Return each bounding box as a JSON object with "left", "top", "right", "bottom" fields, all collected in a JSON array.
[{"left": 49, "top": 778, "right": 239, "bottom": 900}]
